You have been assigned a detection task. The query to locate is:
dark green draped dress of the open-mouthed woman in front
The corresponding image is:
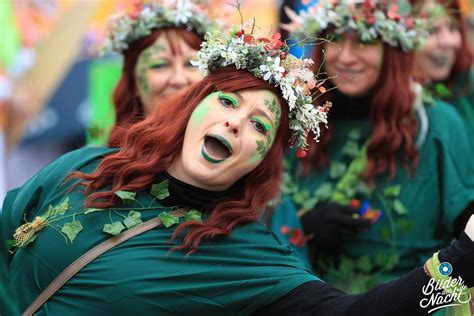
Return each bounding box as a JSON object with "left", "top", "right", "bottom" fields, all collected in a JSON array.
[{"left": 4, "top": 147, "right": 319, "bottom": 315}]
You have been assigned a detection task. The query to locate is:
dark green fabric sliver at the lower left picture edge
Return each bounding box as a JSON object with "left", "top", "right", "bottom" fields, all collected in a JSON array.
[{"left": 0, "top": 217, "right": 20, "bottom": 316}]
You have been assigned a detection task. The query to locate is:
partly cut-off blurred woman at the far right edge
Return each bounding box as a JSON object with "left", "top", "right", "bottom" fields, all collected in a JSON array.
[{"left": 414, "top": 0, "right": 474, "bottom": 130}]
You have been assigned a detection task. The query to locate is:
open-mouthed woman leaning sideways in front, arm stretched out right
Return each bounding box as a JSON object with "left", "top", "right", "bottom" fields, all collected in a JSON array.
[{"left": 2, "top": 22, "right": 474, "bottom": 315}]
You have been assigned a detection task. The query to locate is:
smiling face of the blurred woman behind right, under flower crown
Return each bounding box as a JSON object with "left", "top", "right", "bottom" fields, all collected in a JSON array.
[{"left": 325, "top": 34, "right": 383, "bottom": 97}]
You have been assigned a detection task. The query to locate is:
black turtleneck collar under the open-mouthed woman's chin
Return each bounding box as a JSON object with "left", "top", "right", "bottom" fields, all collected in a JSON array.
[{"left": 157, "top": 172, "right": 243, "bottom": 212}]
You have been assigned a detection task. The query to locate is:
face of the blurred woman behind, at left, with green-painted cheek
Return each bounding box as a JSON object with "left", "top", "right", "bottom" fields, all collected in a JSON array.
[{"left": 135, "top": 30, "right": 202, "bottom": 114}]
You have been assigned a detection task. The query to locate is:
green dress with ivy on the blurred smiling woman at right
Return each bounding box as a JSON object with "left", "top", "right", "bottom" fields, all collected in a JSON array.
[{"left": 273, "top": 101, "right": 474, "bottom": 293}]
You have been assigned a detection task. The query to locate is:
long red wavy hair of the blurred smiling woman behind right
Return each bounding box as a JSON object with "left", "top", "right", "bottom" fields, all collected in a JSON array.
[{"left": 302, "top": 44, "right": 418, "bottom": 184}]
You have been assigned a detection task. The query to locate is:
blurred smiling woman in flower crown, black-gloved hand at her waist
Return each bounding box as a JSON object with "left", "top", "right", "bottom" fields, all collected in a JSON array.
[{"left": 273, "top": 0, "right": 474, "bottom": 293}]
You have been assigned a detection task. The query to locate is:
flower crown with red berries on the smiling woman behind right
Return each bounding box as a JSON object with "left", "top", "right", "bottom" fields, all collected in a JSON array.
[{"left": 285, "top": 0, "right": 428, "bottom": 52}]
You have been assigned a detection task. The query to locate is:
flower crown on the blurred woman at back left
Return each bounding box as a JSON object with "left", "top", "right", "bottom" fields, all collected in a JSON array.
[{"left": 101, "top": 0, "right": 215, "bottom": 53}]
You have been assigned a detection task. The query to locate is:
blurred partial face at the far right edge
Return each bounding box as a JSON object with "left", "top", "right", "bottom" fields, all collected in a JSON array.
[{"left": 415, "top": 3, "right": 462, "bottom": 81}]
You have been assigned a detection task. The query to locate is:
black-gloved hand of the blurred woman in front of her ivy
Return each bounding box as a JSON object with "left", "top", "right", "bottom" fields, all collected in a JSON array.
[{"left": 301, "top": 203, "right": 371, "bottom": 251}]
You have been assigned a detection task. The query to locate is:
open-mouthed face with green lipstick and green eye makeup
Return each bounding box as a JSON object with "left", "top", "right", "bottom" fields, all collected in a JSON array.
[{"left": 167, "top": 90, "right": 281, "bottom": 191}]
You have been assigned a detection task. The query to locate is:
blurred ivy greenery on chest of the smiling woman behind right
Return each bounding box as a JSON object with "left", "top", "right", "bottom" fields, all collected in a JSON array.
[{"left": 282, "top": 129, "right": 413, "bottom": 292}]
